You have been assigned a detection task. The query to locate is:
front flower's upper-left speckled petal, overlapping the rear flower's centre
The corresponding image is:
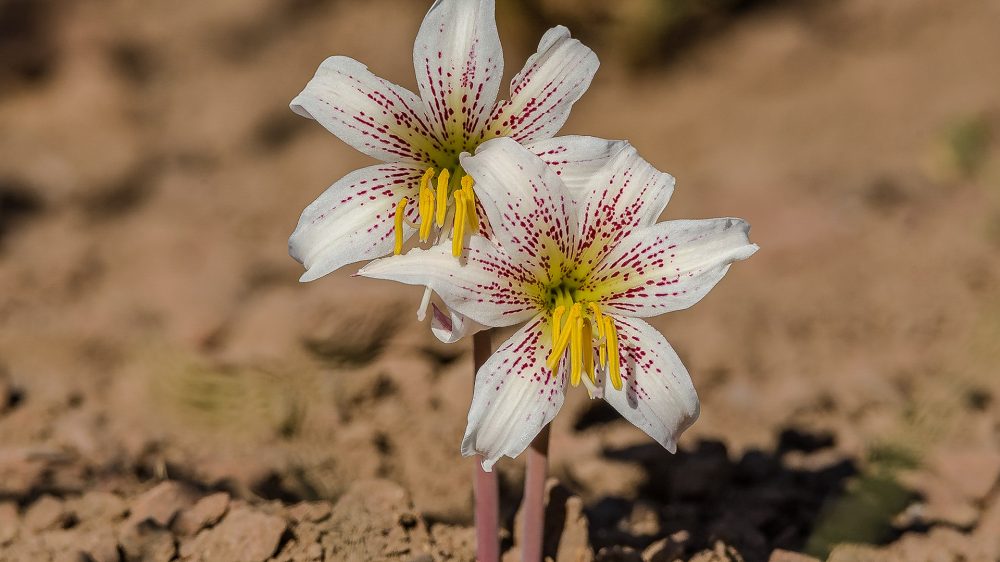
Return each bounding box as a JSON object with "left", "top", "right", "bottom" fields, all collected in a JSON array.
[{"left": 462, "top": 137, "right": 576, "bottom": 283}]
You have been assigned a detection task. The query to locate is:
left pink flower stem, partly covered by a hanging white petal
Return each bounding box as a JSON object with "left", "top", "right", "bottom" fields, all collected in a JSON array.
[{"left": 472, "top": 330, "right": 500, "bottom": 562}]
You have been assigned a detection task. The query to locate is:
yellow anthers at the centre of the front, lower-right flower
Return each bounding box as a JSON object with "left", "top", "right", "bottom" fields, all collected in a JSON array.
[{"left": 546, "top": 288, "right": 622, "bottom": 390}]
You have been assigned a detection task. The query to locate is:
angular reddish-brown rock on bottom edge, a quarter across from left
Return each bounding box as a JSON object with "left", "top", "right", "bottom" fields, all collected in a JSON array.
[{"left": 181, "top": 507, "right": 288, "bottom": 562}]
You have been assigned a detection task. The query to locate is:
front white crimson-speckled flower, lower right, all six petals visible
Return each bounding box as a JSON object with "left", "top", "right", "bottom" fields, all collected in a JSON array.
[{"left": 360, "top": 138, "right": 757, "bottom": 470}]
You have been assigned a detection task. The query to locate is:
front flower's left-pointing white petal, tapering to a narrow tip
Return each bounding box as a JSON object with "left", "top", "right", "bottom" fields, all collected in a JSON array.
[{"left": 358, "top": 236, "right": 540, "bottom": 327}]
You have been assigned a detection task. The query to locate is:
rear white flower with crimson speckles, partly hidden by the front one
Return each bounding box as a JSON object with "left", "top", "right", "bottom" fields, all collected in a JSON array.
[{"left": 288, "top": 0, "right": 598, "bottom": 288}]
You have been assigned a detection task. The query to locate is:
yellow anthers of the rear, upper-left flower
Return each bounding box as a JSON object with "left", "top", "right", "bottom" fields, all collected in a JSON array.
[{"left": 393, "top": 168, "right": 479, "bottom": 258}]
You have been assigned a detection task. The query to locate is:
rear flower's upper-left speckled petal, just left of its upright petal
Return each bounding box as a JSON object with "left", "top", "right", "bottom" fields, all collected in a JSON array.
[{"left": 290, "top": 57, "right": 441, "bottom": 163}]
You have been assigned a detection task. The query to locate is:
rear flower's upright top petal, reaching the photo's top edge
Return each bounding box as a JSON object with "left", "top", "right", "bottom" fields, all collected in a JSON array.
[{"left": 413, "top": 0, "right": 503, "bottom": 147}]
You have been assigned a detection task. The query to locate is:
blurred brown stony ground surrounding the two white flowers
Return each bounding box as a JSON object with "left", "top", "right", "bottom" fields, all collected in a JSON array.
[{"left": 0, "top": 0, "right": 1000, "bottom": 562}]
